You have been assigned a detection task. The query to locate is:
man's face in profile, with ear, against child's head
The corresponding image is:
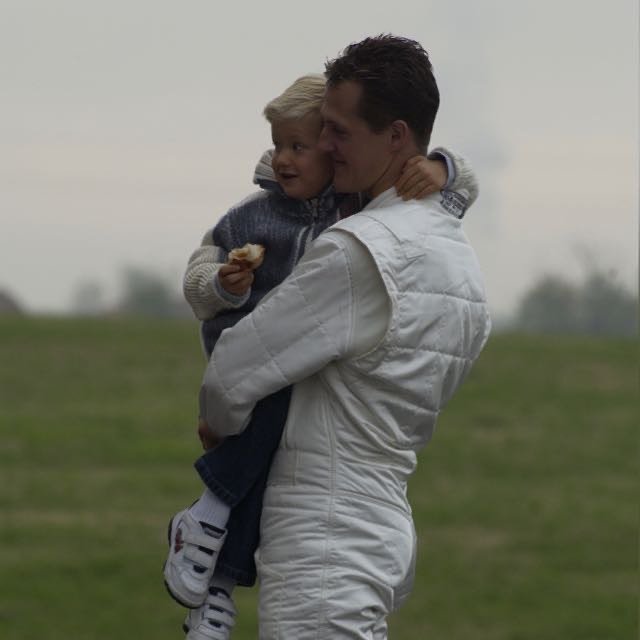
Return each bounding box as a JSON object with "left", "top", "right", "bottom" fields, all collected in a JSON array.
[{"left": 319, "top": 81, "right": 393, "bottom": 197}]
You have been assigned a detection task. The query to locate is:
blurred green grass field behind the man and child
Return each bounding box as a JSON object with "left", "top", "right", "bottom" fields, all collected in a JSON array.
[{"left": 0, "top": 318, "right": 639, "bottom": 640}]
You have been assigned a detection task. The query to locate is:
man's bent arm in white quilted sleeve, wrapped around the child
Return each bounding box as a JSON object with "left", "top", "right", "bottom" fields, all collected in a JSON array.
[{"left": 200, "top": 232, "right": 386, "bottom": 436}]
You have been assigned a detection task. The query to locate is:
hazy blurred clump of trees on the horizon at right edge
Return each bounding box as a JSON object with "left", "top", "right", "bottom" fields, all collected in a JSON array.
[{"left": 514, "top": 270, "right": 638, "bottom": 336}]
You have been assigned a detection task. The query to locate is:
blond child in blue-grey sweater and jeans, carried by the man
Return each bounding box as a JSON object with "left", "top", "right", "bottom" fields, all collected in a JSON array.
[{"left": 164, "top": 75, "right": 477, "bottom": 640}]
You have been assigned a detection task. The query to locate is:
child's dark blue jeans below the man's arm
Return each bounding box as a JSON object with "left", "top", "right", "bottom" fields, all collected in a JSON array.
[{"left": 195, "top": 387, "right": 291, "bottom": 587}]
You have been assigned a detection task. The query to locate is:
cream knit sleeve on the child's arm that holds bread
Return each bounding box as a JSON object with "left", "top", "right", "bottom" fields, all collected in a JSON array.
[{"left": 182, "top": 231, "right": 251, "bottom": 320}]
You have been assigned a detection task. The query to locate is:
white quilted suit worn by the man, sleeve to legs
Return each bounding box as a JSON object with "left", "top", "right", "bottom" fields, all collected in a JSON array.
[{"left": 201, "top": 189, "right": 490, "bottom": 640}]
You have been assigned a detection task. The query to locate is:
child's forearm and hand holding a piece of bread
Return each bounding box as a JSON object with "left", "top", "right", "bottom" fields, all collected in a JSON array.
[{"left": 182, "top": 231, "right": 253, "bottom": 320}]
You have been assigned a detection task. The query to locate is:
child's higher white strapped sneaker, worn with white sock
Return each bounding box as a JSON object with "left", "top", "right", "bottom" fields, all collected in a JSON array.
[{"left": 164, "top": 509, "right": 227, "bottom": 609}]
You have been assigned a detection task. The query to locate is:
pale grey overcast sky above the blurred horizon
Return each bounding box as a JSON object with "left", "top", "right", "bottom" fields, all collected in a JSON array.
[{"left": 0, "top": 0, "right": 638, "bottom": 313}]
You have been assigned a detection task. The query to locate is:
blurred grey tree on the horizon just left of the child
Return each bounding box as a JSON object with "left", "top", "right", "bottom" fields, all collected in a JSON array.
[{"left": 117, "top": 267, "right": 188, "bottom": 317}]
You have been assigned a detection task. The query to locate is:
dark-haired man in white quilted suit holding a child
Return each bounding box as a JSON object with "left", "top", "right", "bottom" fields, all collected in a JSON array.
[{"left": 201, "top": 36, "right": 490, "bottom": 640}]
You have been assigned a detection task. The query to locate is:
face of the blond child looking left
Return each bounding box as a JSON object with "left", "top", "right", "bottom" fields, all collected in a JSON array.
[{"left": 271, "top": 113, "right": 333, "bottom": 200}]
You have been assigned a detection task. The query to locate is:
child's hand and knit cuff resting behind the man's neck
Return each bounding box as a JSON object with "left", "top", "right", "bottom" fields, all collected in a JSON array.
[{"left": 395, "top": 147, "right": 478, "bottom": 211}]
